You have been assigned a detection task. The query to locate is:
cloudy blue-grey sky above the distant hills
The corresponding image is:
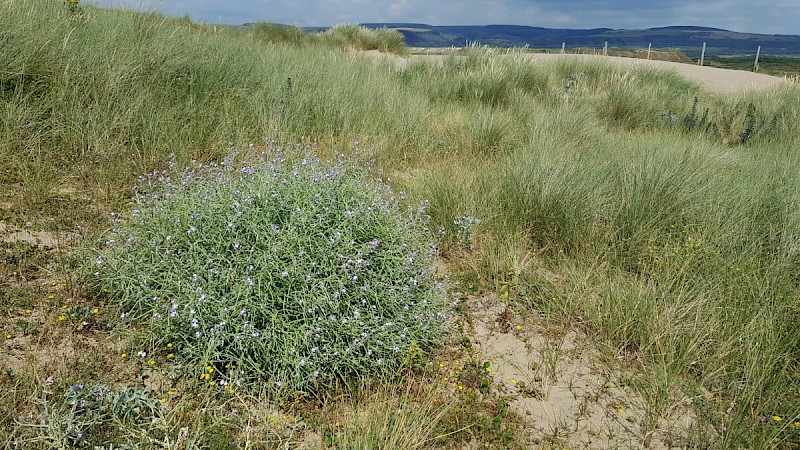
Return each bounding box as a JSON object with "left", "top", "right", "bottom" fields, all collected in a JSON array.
[{"left": 85, "top": 0, "right": 800, "bottom": 34}]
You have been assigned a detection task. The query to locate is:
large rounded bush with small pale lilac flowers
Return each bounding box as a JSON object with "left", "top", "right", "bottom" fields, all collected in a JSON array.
[{"left": 94, "top": 146, "right": 444, "bottom": 393}]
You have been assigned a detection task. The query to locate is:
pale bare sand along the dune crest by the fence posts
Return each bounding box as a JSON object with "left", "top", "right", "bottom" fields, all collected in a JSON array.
[{"left": 364, "top": 51, "right": 788, "bottom": 93}]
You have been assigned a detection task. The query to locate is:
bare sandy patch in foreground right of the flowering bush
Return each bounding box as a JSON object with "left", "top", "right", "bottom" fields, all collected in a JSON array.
[{"left": 467, "top": 296, "right": 694, "bottom": 449}]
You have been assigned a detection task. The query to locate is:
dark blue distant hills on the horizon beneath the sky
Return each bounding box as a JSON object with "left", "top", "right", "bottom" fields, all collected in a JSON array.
[{"left": 306, "top": 23, "right": 800, "bottom": 56}]
